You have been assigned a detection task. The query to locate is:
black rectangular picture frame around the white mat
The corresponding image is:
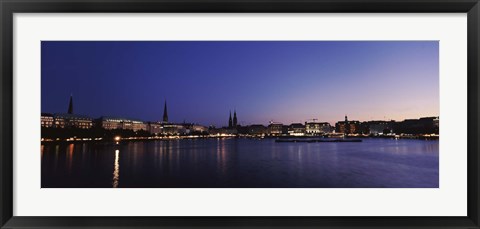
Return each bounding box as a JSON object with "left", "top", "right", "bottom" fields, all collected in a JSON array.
[{"left": 0, "top": 0, "right": 480, "bottom": 228}]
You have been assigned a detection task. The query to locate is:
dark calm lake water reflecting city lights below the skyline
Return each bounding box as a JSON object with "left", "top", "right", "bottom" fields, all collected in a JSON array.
[{"left": 41, "top": 139, "right": 439, "bottom": 188}]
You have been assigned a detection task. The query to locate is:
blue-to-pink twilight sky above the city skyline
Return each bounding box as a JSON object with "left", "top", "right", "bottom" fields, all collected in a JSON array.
[{"left": 41, "top": 41, "right": 440, "bottom": 126}]
